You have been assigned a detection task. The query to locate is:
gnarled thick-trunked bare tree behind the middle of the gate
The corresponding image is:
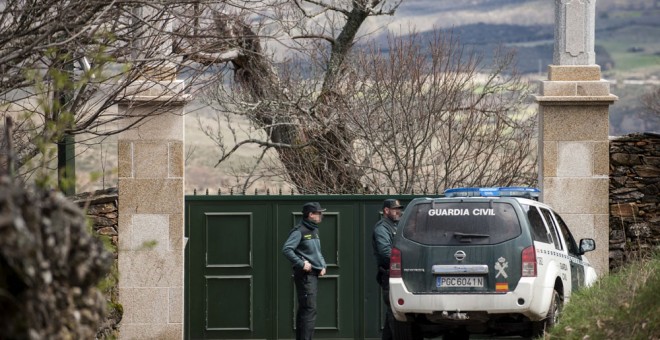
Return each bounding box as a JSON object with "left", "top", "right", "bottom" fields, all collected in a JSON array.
[{"left": 196, "top": 0, "right": 400, "bottom": 192}]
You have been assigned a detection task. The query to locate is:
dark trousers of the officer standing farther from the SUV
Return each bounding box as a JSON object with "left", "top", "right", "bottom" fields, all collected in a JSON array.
[{"left": 293, "top": 270, "right": 319, "bottom": 340}]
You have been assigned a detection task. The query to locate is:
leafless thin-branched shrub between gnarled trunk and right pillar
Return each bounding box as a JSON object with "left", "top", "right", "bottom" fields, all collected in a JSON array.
[{"left": 344, "top": 31, "right": 536, "bottom": 193}]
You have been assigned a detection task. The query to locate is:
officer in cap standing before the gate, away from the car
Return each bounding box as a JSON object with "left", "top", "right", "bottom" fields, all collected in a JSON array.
[{"left": 282, "top": 202, "right": 326, "bottom": 340}]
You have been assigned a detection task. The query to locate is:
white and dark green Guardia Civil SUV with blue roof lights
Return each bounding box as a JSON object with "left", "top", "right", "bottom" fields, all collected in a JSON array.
[{"left": 390, "top": 187, "right": 596, "bottom": 339}]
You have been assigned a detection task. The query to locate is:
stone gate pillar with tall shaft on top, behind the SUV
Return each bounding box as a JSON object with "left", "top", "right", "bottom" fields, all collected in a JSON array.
[{"left": 535, "top": 0, "right": 617, "bottom": 274}]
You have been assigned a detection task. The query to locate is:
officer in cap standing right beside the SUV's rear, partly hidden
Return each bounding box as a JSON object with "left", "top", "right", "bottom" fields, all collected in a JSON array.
[{"left": 371, "top": 198, "right": 403, "bottom": 340}]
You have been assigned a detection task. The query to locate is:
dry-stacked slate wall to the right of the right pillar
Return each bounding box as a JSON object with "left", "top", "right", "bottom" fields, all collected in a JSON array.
[{"left": 609, "top": 133, "right": 660, "bottom": 270}]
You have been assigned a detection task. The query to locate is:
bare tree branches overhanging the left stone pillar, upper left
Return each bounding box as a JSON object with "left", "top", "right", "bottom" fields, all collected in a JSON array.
[{"left": 0, "top": 0, "right": 237, "bottom": 187}]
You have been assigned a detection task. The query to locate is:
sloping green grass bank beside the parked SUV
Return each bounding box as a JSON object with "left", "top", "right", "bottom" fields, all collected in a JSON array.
[{"left": 545, "top": 253, "right": 660, "bottom": 340}]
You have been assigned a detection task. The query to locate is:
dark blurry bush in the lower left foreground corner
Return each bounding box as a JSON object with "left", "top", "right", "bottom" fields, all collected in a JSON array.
[{"left": 0, "top": 176, "right": 112, "bottom": 339}]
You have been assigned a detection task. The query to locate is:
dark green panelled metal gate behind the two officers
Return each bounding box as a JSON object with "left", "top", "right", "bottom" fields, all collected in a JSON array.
[{"left": 184, "top": 195, "right": 428, "bottom": 339}]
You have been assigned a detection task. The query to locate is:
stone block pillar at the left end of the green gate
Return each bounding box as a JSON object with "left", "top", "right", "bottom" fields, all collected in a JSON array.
[{"left": 118, "top": 80, "right": 186, "bottom": 339}]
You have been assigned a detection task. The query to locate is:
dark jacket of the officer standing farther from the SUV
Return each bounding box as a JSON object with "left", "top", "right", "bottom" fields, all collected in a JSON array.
[{"left": 282, "top": 219, "right": 326, "bottom": 271}]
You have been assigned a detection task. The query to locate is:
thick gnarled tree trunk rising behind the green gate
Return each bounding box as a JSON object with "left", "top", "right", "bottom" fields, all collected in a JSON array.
[{"left": 220, "top": 10, "right": 367, "bottom": 193}]
